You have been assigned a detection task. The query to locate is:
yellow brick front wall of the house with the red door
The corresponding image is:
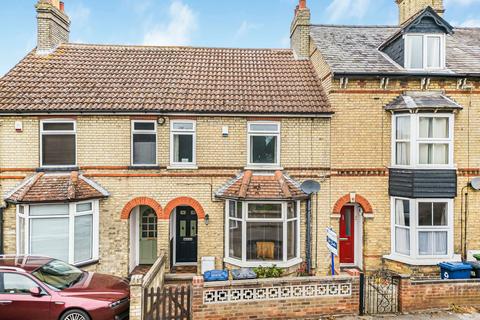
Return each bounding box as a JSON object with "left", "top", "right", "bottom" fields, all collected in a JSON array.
[{"left": 311, "top": 40, "right": 480, "bottom": 273}]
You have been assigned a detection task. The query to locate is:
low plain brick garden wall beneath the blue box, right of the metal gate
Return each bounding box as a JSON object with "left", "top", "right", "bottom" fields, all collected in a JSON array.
[{"left": 399, "top": 278, "right": 480, "bottom": 312}]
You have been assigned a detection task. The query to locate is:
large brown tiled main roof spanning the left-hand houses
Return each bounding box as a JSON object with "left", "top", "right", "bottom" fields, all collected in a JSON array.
[{"left": 0, "top": 44, "right": 331, "bottom": 114}]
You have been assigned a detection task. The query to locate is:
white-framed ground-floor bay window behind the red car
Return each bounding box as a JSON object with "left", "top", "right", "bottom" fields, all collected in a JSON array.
[{"left": 17, "top": 200, "right": 99, "bottom": 265}]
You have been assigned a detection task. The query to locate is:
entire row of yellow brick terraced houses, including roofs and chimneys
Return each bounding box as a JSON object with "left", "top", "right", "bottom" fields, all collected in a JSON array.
[{"left": 0, "top": 0, "right": 480, "bottom": 275}]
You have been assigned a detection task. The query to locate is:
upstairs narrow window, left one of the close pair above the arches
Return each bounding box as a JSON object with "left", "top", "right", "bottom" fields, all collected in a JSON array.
[{"left": 131, "top": 120, "right": 157, "bottom": 166}]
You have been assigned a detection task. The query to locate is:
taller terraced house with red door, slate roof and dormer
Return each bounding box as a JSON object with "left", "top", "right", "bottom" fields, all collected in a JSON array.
[{"left": 292, "top": 0, "right": 480, "bottom": 275}]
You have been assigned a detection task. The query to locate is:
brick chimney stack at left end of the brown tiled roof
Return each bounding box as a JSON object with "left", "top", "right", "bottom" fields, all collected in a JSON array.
[{"left": 35, "top": 0, "right": 70, "bottom": 54}]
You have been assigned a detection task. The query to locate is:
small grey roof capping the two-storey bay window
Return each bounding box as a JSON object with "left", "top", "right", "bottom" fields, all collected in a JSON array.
[{"left": 385, "top": 91, "right": 463, "bottom": 111}]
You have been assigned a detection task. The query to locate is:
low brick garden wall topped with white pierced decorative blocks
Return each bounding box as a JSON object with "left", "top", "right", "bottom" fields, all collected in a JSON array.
[{"left": 189, "top": 276, "right": 359, "bottom": 320}]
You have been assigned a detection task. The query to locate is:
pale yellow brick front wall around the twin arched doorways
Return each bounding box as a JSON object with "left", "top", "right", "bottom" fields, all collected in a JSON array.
[{"left": 0, "top": 116, "right": 330, "bottom": 276}]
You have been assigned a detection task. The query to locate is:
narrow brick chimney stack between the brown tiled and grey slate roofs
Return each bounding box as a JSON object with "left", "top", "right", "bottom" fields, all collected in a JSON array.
[{"left": 290, "top": 0, "right": 310, "bottom": 60}]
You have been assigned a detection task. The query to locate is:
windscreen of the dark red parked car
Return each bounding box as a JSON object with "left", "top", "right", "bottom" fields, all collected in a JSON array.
[{"left": 32, "top": 260, "right": 83, "bottom": 290}]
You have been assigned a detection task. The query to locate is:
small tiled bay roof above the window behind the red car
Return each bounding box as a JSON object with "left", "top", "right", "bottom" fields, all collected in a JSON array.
[{"left": 5, "top": 171, "right": 109, "bottom": 203}]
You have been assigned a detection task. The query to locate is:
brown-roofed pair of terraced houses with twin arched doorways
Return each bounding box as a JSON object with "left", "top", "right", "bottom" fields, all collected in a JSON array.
[{"left": 0, "top": 0, "right": 332, "bottom": 275}]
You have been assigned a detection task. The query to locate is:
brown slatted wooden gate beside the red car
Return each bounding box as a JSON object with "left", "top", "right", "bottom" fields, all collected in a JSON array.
[{"left": 144, "top": 285, "right": 192, "bottom": 320}]
